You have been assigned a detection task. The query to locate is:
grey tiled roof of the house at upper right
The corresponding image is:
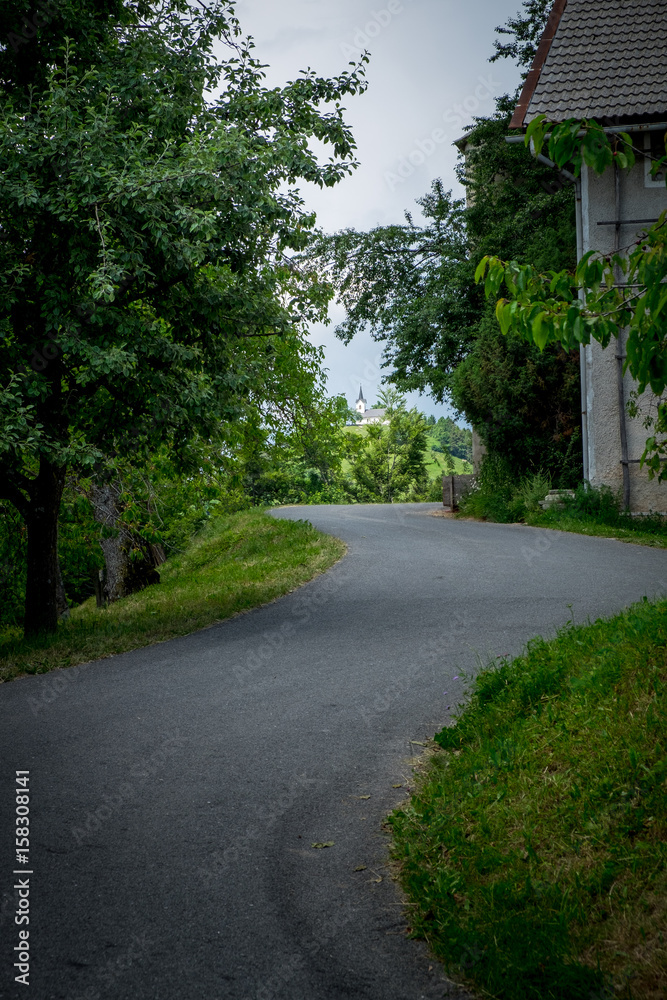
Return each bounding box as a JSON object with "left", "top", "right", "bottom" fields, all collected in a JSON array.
[{"left": 512, "top": 0, "right": 667, "bottom": 128}]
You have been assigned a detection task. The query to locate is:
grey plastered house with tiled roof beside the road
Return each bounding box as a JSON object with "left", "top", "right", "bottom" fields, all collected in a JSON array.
[{"left": 508, "top": 0, "right": 667, "bottom": 511}]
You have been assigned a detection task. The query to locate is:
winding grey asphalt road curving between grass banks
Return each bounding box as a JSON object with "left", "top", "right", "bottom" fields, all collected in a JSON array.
[{"left": 0, "top": 504, "right": 667, "bottom": 1000}]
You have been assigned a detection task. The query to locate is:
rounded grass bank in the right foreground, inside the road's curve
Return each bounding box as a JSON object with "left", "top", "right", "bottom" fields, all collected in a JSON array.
[{"left": 390, "top": 601, "right": 667, "bottom": 1000}]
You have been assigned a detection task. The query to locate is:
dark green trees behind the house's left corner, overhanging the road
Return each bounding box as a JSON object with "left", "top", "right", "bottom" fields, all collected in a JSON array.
[{"left": 310, "top": 0, "right": 581, "bottom": 485}]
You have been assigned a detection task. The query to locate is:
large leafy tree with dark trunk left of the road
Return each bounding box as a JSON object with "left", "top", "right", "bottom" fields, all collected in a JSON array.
[{"left": 0, "top": 0, "right": 365, "bottom": 635}]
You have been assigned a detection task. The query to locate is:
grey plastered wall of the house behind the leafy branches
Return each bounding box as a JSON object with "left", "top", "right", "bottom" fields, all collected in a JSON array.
[{"left": 580, "top": 148, "right": 667, "bottom": 511}]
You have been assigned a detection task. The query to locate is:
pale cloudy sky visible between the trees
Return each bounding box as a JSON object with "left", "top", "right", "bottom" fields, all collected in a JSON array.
[{"left": 237, "top": 0, "right": 522, "bottom": 416}]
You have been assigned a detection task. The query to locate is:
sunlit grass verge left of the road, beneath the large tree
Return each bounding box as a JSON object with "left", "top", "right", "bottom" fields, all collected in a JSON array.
[{"left": 0, "top": 510, "right": 345, "bottom": 681}]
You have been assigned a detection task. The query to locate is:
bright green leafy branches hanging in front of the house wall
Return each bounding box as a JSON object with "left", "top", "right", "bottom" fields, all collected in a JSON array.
[{"left": 476, "top": 121, "right": 667, "bottom": 480}]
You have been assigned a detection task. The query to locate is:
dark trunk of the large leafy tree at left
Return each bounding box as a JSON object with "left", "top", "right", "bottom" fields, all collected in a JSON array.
[{"left": 24, "top": 456, "right": 66, "bottom": 638}]
